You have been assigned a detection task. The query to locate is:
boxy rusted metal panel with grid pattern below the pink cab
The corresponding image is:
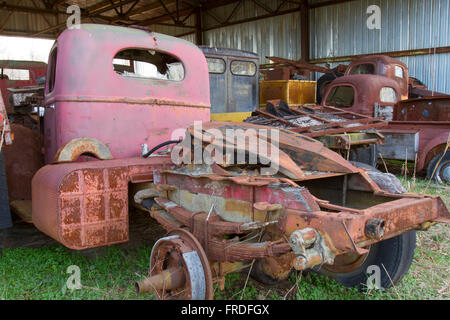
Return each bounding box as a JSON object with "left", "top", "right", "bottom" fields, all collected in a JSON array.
[{"left": 32, "top": 157, "right": 169, "bottom": 250}]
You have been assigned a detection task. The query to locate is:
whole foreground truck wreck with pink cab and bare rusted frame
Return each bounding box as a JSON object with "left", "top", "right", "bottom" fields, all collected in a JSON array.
[{"left": 0, "top": 24, "right": 450, "bottom": 299}]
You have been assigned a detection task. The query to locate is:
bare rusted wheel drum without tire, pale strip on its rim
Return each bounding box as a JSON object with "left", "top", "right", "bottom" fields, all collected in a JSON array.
[{"left": 150, "top": 229, "right": 213, "bottom": 300}]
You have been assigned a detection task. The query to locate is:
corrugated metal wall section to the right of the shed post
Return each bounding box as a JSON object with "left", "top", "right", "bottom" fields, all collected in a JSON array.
[{"left": 310, "top": 0, "right": 450, "bottom": 92}]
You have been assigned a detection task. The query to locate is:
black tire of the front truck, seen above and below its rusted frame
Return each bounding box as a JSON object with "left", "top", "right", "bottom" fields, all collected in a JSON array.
[{"left": 317, "top": 162, "right": 416, "bottom": 290}]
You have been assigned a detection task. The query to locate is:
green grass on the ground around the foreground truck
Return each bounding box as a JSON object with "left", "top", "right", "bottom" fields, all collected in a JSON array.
[{"left": 0, "top": 179, "right": 450, "bottom": 300}]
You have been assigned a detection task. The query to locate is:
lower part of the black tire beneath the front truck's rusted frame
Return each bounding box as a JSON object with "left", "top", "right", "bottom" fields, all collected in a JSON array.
[{"left": 318, "top": 231, "right": 416, "bottom": 290}]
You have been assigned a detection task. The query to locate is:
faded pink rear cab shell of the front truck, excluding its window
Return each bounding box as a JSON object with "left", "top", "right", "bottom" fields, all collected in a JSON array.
[{"left": 45, "top": 24, "right": 210, "bottom": 163}]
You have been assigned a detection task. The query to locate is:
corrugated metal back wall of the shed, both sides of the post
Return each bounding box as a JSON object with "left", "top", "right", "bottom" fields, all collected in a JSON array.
[{"left": 195, "top": 0, "right": 450, "bottom": 92}]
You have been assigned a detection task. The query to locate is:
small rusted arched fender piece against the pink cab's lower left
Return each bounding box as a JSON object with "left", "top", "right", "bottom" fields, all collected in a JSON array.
[{"left": 53, "top": 137, "right": 113, "bottom": 163}]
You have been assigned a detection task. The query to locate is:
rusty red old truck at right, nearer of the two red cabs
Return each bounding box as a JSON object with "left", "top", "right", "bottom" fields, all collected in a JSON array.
[{"left": 322, "top": 74, "right": 450, "bottom": 171}]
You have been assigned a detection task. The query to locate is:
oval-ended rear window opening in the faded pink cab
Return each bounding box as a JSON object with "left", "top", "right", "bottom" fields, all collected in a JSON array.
[{"left": 112, "top": 49, "right": 184, "bottom": 81}]
